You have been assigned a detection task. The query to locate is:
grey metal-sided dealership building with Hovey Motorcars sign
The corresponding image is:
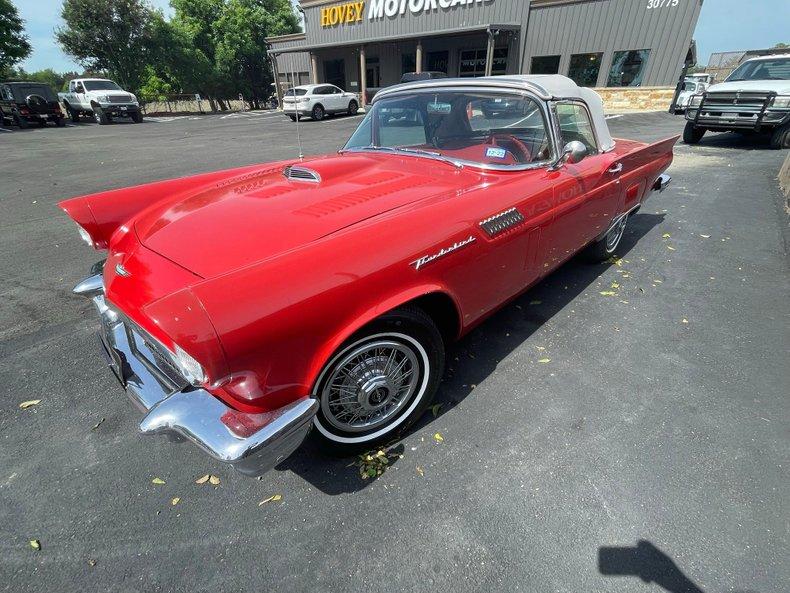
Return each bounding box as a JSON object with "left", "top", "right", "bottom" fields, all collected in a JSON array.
[{"left": 267, "top": 0, "right": 703, "bottom": 105}]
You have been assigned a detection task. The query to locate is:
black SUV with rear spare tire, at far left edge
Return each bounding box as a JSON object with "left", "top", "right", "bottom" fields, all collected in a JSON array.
[{"left": 0, "top": 82, "right": 66, "bottom": 128}]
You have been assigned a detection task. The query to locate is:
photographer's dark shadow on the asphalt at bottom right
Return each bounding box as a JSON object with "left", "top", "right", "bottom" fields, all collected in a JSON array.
[{"left": 598, "top": 540, "right": 755, "bottom": 593}]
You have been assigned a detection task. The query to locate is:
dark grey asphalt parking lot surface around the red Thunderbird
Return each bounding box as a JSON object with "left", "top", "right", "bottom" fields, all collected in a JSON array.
[{"left": 0, "top": 113, "right": 790, "bottom": 593}]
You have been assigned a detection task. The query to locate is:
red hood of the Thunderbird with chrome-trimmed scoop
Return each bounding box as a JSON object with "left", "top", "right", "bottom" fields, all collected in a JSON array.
[{"left": 134, "top": 153, "right": 480, "bottom": 278}]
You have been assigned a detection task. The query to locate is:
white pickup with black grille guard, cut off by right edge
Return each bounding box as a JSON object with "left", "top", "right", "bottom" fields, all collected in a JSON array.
[{"left": 683, "top": 54, "right": 790, "bottom": 149}]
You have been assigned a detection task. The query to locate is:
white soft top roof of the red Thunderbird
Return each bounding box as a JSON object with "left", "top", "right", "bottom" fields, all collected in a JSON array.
[{"left": 374, "top": 74, "right": 614, "bottom": 151}]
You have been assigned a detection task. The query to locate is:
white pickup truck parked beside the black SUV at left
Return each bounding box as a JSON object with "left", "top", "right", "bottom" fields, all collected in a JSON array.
[{"left": 58, "top": 78, "right": 143, "bottom": 125}]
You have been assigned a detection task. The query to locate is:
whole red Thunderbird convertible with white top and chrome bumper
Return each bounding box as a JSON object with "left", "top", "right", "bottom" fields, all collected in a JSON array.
[{"left": 60, "top": 75, "right": 677, "bottom": 475}]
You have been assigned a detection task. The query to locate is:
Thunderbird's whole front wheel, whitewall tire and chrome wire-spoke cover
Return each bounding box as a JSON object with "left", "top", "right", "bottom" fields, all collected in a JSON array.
[{"left": 313, "top": 307, "right": 444, "bottom": 454}]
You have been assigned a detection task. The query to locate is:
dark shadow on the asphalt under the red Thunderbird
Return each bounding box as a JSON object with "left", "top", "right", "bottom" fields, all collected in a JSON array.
[{"left": 276, "top": 212, "right": 665, "bottom": 495}]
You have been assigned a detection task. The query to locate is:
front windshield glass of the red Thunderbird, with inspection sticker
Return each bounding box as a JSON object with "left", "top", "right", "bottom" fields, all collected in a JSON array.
[{"left": 344, "top": 91, "right": 551, "bottom": 167}]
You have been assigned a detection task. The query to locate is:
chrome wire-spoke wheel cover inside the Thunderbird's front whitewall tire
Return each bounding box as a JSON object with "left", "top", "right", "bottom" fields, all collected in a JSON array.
[{"left": 321, "top": 340, "right": 419, "bottom": 432}]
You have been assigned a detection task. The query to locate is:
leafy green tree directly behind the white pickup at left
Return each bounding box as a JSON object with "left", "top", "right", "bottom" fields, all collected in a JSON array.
[{"left": 55, "top": 0, "right": 156, "bottom": 91}]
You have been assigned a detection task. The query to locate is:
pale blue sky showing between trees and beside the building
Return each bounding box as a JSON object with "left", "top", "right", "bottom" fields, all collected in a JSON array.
[{"left": 12, "top": 0, "right": 790, "bottom": 72}]
